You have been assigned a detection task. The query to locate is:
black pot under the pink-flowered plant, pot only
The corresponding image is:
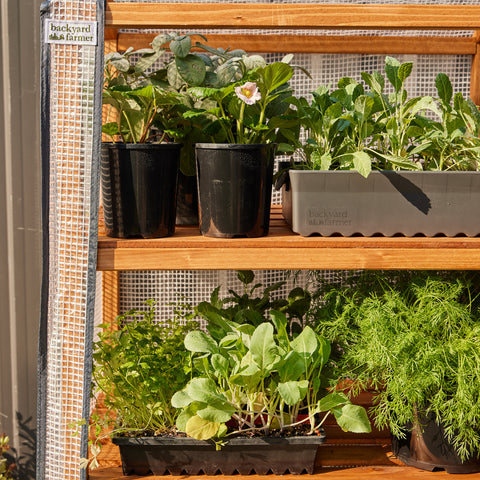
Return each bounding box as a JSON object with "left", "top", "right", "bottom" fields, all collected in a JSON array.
[{"left": 195, "top": 143, "right": 276, "bottom": 238}]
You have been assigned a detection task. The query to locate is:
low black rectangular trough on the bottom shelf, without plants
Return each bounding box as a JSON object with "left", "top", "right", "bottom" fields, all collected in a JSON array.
[{"left": 113, "top": 432, "right": 325, "bottom": 475}]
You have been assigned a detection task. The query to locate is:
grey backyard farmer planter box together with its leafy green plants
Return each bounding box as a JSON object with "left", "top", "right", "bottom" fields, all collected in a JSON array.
[{"left": 283, "top": 57, "right": 480, "bottom": 236}]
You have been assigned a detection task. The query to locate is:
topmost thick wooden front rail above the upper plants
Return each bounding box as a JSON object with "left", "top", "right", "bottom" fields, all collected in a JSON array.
[{"left": 105, "top": 2, "right": 480, "bottom": 30}]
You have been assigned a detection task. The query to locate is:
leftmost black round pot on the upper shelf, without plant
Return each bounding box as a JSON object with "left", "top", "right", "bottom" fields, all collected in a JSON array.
[{"left": 101, "top": 143, "right": 181, "bottom": 238}]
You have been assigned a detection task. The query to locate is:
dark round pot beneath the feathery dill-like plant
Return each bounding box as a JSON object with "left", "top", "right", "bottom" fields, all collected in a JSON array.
[{"left": 392, "top": 416, "right": 480, "bottom": 474}]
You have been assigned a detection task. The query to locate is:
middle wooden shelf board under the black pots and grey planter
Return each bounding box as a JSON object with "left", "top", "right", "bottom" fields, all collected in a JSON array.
[{"left": 97, "top": 206, "right": 480, "bottom": 271}]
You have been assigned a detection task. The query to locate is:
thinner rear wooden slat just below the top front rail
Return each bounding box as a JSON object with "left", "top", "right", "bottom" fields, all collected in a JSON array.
[{"left": 118, "top": 33, "right": 477, "bottom": 55}]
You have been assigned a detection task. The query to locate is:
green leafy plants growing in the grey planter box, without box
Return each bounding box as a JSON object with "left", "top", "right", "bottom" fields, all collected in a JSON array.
[{"left": 291, "top": 57, "right": 480, "bottom": 177}]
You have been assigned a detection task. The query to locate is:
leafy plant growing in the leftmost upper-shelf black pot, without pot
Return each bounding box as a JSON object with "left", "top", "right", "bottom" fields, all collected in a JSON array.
[{"left": 102, "top": 33, "right": 206, "bottom": 143}]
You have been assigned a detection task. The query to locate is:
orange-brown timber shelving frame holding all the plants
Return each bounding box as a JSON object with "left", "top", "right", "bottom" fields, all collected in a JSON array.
[{"left": 94, "top": 1, "right": 480, "bottom": 480}]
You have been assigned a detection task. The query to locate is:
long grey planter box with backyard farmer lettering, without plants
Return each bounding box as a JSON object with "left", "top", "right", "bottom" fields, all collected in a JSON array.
[{"left": 282, "top": 170, "right": 480, "bottom": 237}]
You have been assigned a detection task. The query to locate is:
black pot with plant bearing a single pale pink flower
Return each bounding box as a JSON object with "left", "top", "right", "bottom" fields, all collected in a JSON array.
[{"left": 189, "top": 56, "right": 298, "bottom": 238}]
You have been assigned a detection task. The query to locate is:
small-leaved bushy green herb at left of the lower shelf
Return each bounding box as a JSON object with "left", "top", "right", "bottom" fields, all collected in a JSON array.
[{"left": 93, "top": 300, "right": 198, "bottom": 435}]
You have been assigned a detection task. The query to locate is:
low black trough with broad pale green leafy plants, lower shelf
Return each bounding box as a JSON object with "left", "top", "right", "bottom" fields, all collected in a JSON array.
[{"left": 110, "top": 271, "right": 370, "bottom": 475}]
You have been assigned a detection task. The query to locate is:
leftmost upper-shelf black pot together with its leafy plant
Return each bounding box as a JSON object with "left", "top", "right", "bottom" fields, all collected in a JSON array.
[{"left": 102, "top": 34, "right": 208, "bottom": 238}]
